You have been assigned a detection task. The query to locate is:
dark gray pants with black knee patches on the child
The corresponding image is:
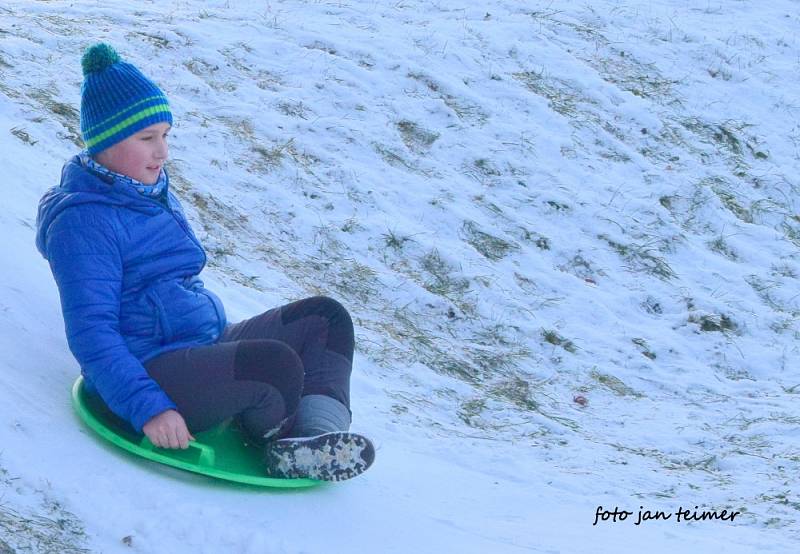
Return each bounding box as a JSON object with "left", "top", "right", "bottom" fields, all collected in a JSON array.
[{"left": 145, "top": 296, "right": 354, "bottom": 440}]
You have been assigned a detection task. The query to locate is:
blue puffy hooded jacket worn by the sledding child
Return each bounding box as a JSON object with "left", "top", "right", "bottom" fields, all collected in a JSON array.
[{"left": 36, "top": 156, "right": 226, "bottom": 432}]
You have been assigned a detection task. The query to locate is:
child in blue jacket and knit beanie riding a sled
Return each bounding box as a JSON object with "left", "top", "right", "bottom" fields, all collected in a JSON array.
[{"left": 36, "top": 43, "right": 375, "bottom": 481}]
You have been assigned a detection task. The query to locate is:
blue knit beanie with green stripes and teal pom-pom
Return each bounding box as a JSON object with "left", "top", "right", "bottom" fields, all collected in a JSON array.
[{"left": 81, "top": 42, "right": 172, "bottom": 156}]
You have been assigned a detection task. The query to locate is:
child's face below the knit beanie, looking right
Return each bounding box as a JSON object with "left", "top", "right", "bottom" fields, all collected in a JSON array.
[{"left": 95, "top": 123, "right": 170, "bottom": 185}]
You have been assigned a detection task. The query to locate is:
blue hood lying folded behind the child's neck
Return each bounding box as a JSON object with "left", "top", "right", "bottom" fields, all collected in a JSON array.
[{"left": 36, "top": 155, "right": 169, "bottom": 260}]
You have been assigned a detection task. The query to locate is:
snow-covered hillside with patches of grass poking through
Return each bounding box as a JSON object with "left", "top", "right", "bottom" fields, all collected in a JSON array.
[{"left": 0, "top": 0, "right": 800, "bottom": 553}]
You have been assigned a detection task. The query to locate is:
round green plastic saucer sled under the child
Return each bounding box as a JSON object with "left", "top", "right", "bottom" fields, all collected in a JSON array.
[{"left": 72, "top": 376, "right": 322, "bottom": 488}]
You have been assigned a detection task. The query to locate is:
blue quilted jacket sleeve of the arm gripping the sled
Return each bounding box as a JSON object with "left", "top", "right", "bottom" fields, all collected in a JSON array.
[{"left": 46, "top": 206, "right": 176, "bottom": 432}]
